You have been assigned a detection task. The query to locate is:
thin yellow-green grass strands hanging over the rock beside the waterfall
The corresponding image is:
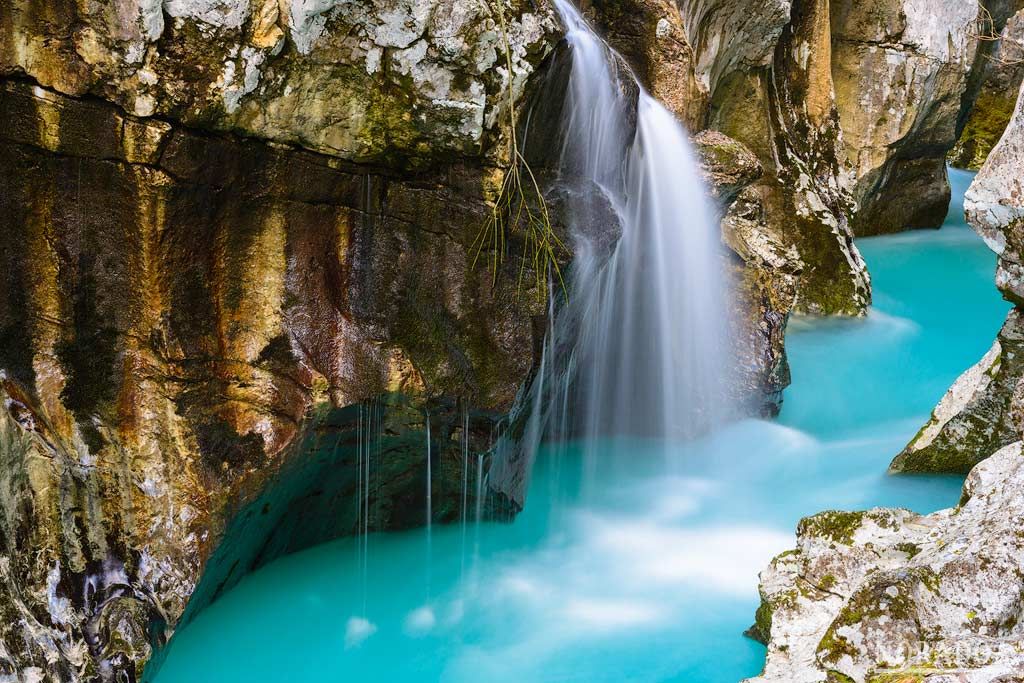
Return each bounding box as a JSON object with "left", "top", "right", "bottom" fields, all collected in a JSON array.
[{"left": 473, "top": 0, "right": 567, "bottom": 300}]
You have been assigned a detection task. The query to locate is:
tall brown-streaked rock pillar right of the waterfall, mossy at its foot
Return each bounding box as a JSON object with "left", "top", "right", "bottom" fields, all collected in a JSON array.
[{"left": 679, "top": 0, "right": 870, "bottom": 315}]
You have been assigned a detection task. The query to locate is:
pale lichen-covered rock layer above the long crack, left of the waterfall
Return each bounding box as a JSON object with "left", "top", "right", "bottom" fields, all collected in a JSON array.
[{"left": 0, "top": 0, "right": 558, "bottom": 165}]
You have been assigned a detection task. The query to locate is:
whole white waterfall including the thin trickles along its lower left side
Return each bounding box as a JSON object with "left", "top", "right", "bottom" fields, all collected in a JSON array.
[{"left": 493, "top": 0, "right": 731, "bottom": 504}]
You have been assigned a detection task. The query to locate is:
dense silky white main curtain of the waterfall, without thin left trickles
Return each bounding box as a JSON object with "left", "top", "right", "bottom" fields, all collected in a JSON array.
[{"left": 556, "top": 0, "right": 728, "bottom": 436}]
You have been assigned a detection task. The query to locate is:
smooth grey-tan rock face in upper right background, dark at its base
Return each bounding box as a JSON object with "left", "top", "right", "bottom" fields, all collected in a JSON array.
[{"left": 831, "top": 0, "right": 987, "bottom": 234}]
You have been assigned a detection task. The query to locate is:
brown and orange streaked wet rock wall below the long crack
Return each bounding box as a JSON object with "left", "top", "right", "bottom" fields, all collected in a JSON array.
[{"left": 0, "top": 72, "right": 544, "bottom": 681}]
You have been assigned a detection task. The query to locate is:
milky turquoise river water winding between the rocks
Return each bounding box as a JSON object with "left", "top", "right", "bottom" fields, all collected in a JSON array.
[{"left": 157, "top": 171, "right": 1008, "bottom": 683}]
